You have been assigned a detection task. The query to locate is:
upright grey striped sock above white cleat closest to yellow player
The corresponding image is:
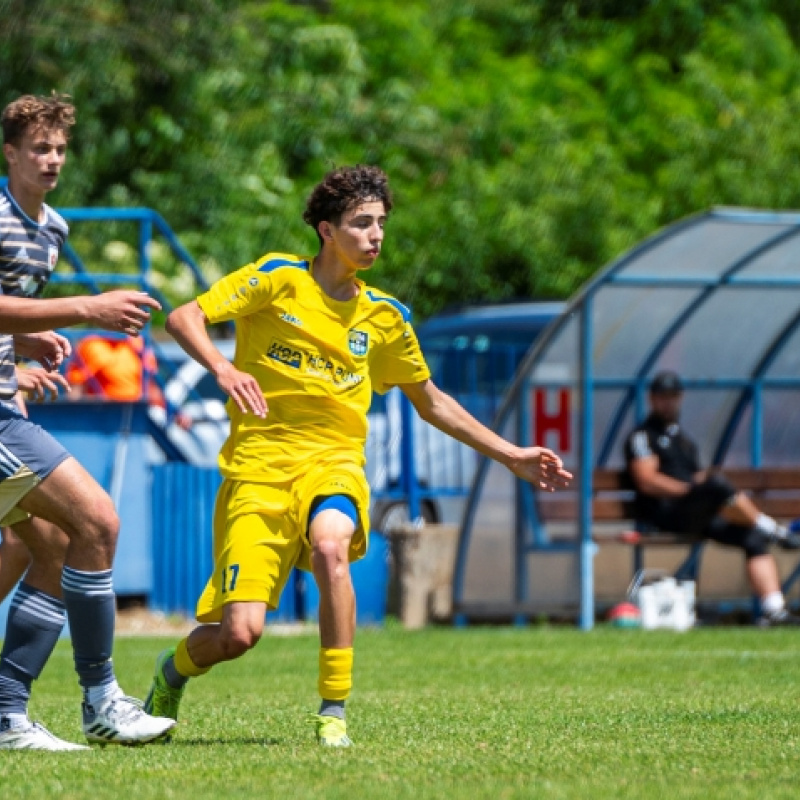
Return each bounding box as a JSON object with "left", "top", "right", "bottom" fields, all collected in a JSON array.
[{"left": 61, "top": 567, "right": 117, "bottom": 689}]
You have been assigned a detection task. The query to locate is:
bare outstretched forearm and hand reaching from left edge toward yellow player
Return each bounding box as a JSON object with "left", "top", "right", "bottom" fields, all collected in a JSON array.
[{"left": 0, "top": 289, "right": 161, "bottom": 336}]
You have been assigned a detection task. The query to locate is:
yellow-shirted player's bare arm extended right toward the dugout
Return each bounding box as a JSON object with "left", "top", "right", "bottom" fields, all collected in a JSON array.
[{"left": 400, "top": 380, "right": 572, "bottom": 491}]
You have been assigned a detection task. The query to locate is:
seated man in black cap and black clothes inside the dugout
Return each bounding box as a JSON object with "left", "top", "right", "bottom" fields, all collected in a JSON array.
[{"left": 625, "top": 372, "right": 800, "bottom": 625}]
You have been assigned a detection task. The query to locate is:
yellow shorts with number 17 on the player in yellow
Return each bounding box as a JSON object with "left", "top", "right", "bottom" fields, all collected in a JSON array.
[{"left": 197, "top": 464, "right": 369, "bottom": 622}]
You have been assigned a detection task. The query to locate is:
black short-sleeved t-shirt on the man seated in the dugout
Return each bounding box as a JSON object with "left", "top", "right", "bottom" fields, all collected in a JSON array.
[{"left": 625, "top": 414, "right": 702, "bottom": 520}]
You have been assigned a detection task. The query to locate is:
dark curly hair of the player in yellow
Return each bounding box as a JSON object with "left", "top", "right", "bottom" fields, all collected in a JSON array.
[{"left": 303, "top": 164, "right": 392, "bottom": 242}]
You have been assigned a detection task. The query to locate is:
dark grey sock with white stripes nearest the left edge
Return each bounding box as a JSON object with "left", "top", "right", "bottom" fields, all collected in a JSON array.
[{"left": 0, "top": 583, "right": 66, "bottom": 715}]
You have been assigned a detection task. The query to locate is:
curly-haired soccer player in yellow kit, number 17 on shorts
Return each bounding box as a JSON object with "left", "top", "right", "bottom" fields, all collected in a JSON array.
[{"left": 145, "top": 166, "right": 571, "bottom": 747}]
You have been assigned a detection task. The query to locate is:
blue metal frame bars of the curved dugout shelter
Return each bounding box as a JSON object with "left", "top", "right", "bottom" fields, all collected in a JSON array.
[{"left": 453, "top": 211, "right": 800, "bottom": 630}]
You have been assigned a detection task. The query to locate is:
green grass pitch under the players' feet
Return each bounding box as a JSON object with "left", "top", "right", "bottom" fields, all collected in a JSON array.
[{"left": 0, "top": 625, "right": 800, "bottom": 800}]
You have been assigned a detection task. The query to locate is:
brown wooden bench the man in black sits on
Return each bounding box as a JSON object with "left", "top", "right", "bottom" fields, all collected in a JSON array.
[{"left": 540, "top": 467, "right": 800, "bottom": 591}]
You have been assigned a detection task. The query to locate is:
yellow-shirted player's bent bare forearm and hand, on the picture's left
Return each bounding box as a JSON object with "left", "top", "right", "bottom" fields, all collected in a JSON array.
[{"left": 166, "top": 300, "right": 268, "bottom": 417}]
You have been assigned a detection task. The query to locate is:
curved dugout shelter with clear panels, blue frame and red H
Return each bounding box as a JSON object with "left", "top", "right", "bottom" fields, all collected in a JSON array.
[{"left": 453, "top": 208, "right": 800, "bottom": 629}]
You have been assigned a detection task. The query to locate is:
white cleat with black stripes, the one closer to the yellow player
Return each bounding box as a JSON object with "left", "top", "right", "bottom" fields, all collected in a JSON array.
[{"left": 83, "top": 695, "right": 177, "bottom": 745}]
